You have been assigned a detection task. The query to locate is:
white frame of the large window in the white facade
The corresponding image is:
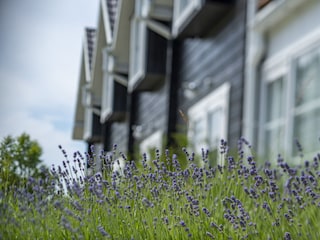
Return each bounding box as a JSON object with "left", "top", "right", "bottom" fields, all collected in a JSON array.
[{"left": 258, "top": 32, "right": 320, "bottom": 163}]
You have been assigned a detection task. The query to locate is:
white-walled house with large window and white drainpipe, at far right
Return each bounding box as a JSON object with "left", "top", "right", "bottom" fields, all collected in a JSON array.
[{"left": 243, "top": 0, "right": 320, "bottom": 163}]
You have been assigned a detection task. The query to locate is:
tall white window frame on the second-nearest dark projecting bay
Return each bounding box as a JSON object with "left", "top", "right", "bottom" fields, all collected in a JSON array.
[{"left": 128, "top": 0, "right": 147, "bottom": 91}]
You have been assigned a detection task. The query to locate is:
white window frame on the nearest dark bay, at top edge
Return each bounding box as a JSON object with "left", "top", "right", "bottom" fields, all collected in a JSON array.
[{"left": 172, "top": 0, "right": 202, "bottom": 37}]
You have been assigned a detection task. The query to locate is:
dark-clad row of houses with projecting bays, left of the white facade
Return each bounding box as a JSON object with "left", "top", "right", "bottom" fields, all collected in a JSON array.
[{"left": 73, "top": 0, "right": 246, "bottom": 170}]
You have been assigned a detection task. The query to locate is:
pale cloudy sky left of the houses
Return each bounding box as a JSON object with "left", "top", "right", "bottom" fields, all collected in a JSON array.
[{"left": 0, "top": 0, "right": 99, "bottom": 166}]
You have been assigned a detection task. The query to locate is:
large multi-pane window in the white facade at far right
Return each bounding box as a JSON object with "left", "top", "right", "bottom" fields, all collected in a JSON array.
[{"left": 259, "top": 47, "right": 320, "bottom": 162}]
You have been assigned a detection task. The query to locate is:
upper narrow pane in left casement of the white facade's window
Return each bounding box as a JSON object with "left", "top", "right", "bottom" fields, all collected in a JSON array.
[{"left": 266, "top": 77, "right": 284, "bottom": 122}]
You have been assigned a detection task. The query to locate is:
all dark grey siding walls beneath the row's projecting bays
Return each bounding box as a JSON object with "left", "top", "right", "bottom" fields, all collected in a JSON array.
[{"left": 107, "top": 0, "right": 246, "bottom": 154}]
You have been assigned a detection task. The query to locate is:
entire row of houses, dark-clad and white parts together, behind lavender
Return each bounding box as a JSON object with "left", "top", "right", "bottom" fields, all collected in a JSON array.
[{"left": 73, "top": 0, "right": 320, "bottom": 169}]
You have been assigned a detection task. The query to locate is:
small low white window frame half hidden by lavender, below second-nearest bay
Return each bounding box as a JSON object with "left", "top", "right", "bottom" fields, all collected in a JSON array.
[{"left": 139, "top": 130, "right": 163, "bottom": 160}]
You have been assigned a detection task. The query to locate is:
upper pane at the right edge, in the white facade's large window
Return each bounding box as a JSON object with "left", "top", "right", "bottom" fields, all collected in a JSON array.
[{"left": 295, "top": 51, "right": 320, "bottom": 106}]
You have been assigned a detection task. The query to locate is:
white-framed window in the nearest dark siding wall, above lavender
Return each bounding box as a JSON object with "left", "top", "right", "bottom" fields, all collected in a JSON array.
[{"left": 188, "top": 83, "right": 230, "bottom": 164}]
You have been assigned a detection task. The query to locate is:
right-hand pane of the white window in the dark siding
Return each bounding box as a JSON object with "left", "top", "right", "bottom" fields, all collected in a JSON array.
[{"left": 208, "top": 108, "right": 222, "bottom": 149}]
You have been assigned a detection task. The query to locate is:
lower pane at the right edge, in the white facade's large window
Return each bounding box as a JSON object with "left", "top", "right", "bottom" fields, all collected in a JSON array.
[{"left": 293, "top": 109, "right": 320, "bottom": 156}]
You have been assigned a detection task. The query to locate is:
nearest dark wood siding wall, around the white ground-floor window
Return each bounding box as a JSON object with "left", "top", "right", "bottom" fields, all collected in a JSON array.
[{"left": 173, "top": 0, "right": 246, "bottom": 147}]
